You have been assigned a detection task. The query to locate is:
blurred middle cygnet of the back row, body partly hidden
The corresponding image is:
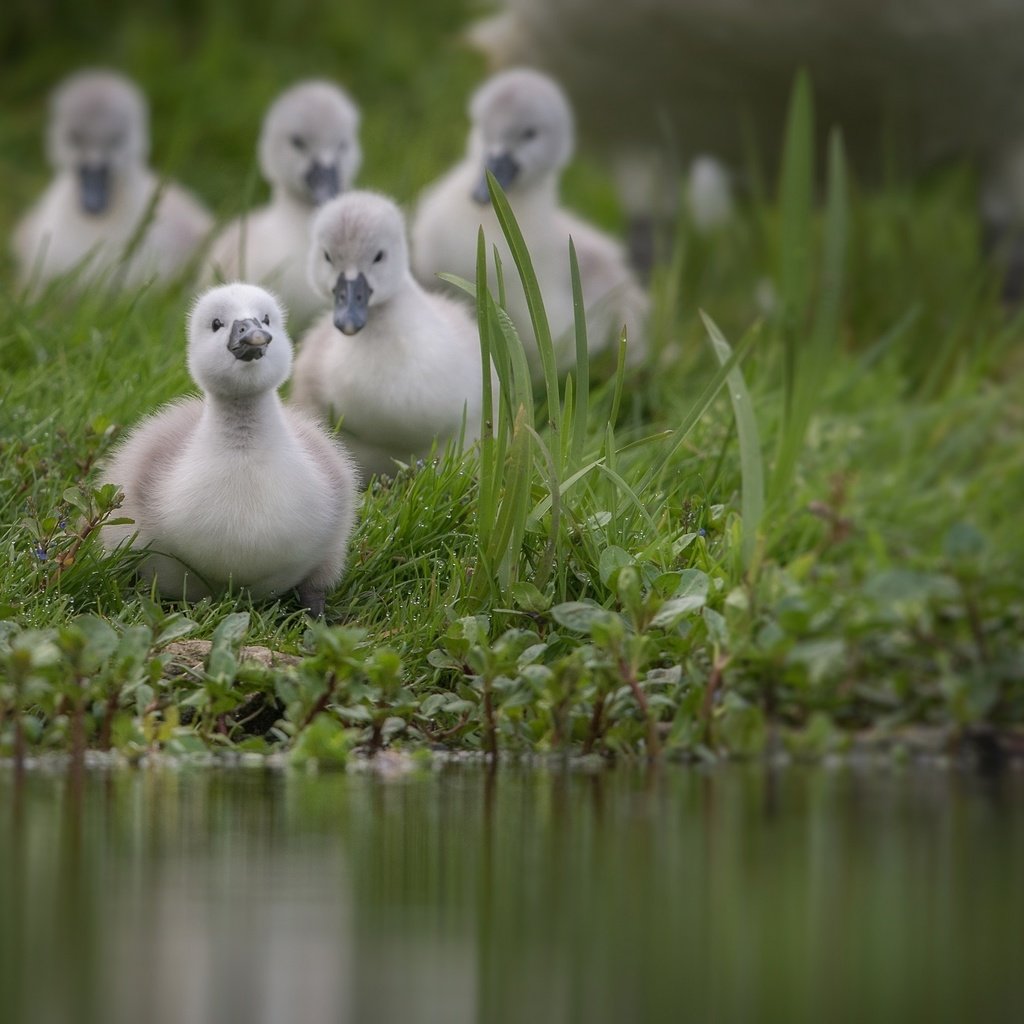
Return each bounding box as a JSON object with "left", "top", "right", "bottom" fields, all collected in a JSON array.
[{"left": 206, "top": 81, "right": 362, "bottom": 324}]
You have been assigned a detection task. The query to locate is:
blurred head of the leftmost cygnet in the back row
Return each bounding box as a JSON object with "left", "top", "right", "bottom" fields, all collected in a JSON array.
[{"left": 47, "top": 71, "right": 150, "bottom": 216}]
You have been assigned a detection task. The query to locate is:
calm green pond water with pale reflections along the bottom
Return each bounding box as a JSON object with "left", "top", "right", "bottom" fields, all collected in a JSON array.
[{"left": 0, "top": 766, "right": 1024, "bottom": 1024}]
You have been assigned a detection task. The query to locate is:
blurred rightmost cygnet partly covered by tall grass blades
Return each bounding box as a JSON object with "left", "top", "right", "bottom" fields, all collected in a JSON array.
[{"left": 412, "top": 69, "right": 648, "bottom": 374}]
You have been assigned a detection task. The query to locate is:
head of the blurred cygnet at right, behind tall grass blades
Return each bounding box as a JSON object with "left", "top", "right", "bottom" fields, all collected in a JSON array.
[{"left": 469, "top": 68, "right": 574, "bottom": 203}]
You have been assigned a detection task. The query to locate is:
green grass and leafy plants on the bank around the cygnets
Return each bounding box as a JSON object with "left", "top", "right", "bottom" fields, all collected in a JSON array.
[{"left": 0, "top": 0, "right": 1024, "bottom": 762}]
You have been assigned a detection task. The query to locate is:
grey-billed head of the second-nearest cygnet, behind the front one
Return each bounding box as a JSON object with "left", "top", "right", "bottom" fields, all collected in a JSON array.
[{"left": 309, "top": 191, "right": 410, "bottom": 335}]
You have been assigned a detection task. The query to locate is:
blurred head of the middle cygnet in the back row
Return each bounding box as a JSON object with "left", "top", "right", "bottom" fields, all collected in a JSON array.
[{"left": 259, "top": 81, "right": 362, "bottom": 206}]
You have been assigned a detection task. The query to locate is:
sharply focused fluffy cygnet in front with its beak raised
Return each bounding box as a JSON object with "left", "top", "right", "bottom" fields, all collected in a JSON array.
[{"left": 102, "top": 284, "right": 358, "bottom": 614}]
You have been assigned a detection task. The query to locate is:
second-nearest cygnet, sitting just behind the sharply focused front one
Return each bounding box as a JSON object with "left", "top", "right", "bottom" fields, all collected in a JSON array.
[{"left": 292, "top": 191, "right": 482, "bottom": 476}]
